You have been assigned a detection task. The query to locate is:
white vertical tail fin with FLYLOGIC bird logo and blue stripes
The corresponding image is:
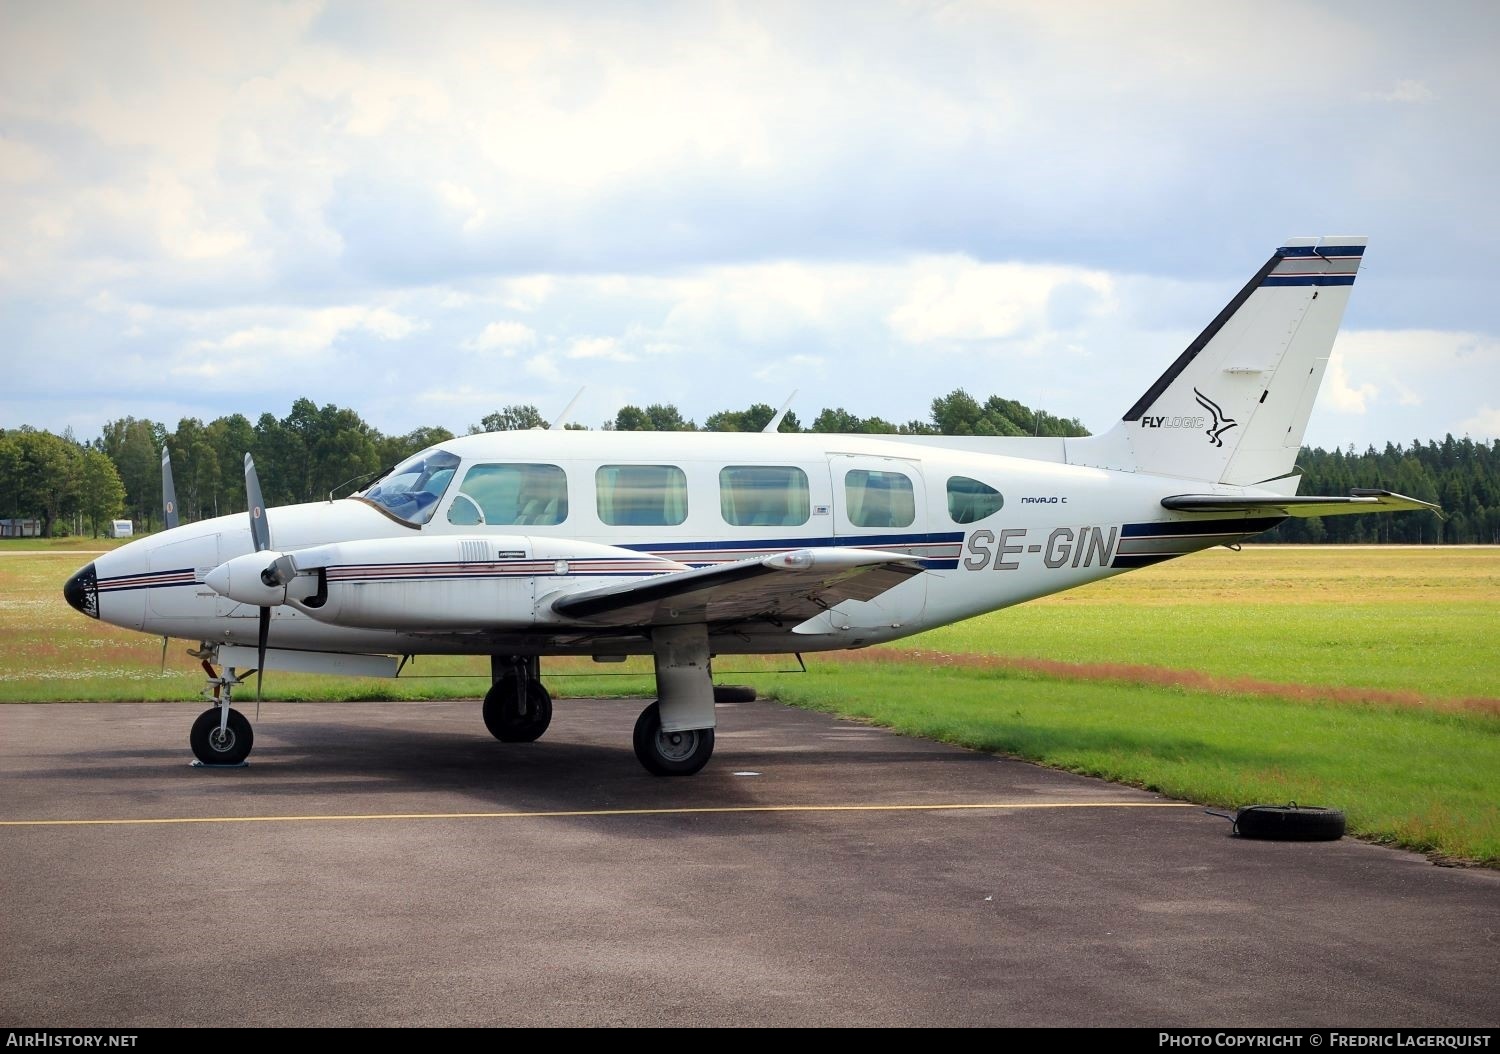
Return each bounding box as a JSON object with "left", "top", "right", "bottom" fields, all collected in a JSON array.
[{"left": 1068, "top": 235, "right": 1368, "bottom": 486}]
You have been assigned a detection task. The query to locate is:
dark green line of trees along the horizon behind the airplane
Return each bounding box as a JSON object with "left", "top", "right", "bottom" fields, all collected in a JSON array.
[{"left": 0, "top": 388, "right": 1500, "bottom": 544}]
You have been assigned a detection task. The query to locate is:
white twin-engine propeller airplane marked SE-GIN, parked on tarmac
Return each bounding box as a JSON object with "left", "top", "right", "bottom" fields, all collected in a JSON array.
[{"left": 63, "top": 237, "right": 1436, "bottom": 775}]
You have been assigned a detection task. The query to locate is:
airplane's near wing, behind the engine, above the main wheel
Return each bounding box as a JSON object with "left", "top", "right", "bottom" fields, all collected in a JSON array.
[{"left": 552, "top": 549, "right": 923, "bottom": 627}]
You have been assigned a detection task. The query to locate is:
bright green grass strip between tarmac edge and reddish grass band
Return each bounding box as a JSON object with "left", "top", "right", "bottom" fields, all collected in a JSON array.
[{"left": 762, "top": 660, "right": 1500, "bottom": 867}]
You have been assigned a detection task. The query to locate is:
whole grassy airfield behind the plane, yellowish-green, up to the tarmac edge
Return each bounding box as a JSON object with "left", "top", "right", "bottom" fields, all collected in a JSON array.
[{"left": 0, "top": 540, "right": 1500, "bottom": 865}]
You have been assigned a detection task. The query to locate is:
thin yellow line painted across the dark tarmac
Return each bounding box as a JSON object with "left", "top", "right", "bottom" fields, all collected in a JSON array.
[{"left": 0, "top": 802, "right": 1199, "bottom": 828}]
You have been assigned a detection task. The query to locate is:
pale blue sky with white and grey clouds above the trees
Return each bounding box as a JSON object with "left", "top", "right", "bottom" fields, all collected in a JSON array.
[{"left": 0, "top": 0, "right": 1500, "bottom": 447}]
